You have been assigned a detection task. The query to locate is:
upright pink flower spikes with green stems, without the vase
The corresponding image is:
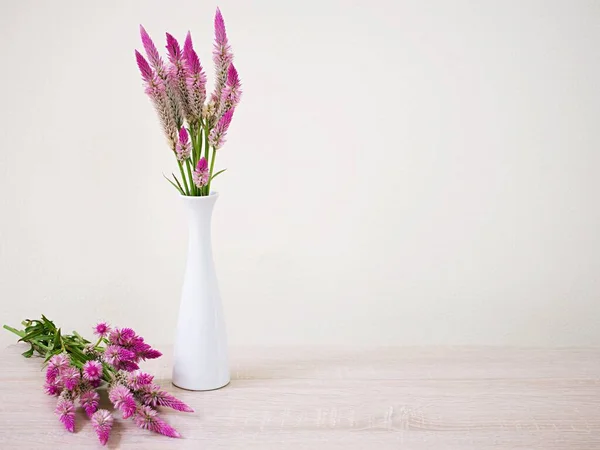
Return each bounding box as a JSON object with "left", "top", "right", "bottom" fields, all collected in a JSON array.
[{"left": 135, "top": 8, "right": 242, "bottom": 196}]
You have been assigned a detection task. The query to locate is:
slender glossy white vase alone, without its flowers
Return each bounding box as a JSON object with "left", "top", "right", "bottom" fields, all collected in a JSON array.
[{"left": 173, "top": 192, "right": 229, "bottom": 391}]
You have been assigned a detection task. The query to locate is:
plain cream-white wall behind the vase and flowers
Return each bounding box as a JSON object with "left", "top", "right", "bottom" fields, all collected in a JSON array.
[{"left": 0, "top": 0, "right": 600, "bottom": 346}]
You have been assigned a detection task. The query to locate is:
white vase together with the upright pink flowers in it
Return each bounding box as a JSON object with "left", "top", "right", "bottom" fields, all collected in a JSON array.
[{"left": 135, "top": 9, "right": 241, "bottom": 391}]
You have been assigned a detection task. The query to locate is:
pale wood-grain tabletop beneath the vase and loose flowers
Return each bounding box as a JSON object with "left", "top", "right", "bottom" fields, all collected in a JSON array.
[{"left": 0, "top": 345, "right": 600, "bottom": 450}]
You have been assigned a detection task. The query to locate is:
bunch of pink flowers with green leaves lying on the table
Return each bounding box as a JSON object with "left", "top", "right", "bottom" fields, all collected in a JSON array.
[{"left": 4, "top": 315, "right": 194, "bottom": 445}]
